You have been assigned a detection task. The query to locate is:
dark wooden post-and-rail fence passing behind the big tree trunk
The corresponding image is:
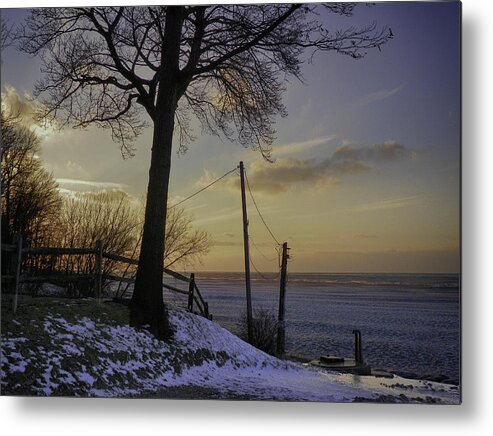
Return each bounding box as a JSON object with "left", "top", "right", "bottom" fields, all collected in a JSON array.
[{"left": 1, "top": 235, "right": 212, "bottom": 319}]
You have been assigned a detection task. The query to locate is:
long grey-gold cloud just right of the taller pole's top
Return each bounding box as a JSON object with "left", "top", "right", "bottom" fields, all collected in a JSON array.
[{"left": 244, "top": 141, "right": 415, "bottom": 194}]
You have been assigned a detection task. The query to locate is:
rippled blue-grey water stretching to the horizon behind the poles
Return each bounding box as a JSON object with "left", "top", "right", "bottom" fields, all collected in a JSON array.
[{"left": 163, "top": 273, "right": 460, "bottom": 379}]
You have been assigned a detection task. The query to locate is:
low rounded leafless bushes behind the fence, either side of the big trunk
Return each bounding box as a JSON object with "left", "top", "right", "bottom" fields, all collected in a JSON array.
[{"left": 50, "top": 191, "right": 210, "bottom": 277}]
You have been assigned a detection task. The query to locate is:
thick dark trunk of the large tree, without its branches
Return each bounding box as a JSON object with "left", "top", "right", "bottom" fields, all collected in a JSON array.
[{"left": 130, "top": 7, "right": 183, "bottom": 339}]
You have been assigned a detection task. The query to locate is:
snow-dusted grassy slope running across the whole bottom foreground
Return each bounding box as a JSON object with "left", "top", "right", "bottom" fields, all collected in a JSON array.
[{"left": 1, "top": 310, "right": 459, "bottom": 404}]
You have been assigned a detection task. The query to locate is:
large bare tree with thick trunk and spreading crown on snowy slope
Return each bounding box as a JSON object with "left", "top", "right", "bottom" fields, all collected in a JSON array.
[{"left": 19, "top": 3, "right": 392, "bottom": 337}]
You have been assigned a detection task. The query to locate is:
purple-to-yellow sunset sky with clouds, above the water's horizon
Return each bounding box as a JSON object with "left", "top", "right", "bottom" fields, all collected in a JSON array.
[{"left": 1, "top": 2, "right": 460, "bottom": 273}]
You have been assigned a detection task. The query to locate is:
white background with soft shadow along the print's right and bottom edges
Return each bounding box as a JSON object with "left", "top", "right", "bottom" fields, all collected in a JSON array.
[{"left": 0, "top": 0, "right": 493, "bottom": 436}]
